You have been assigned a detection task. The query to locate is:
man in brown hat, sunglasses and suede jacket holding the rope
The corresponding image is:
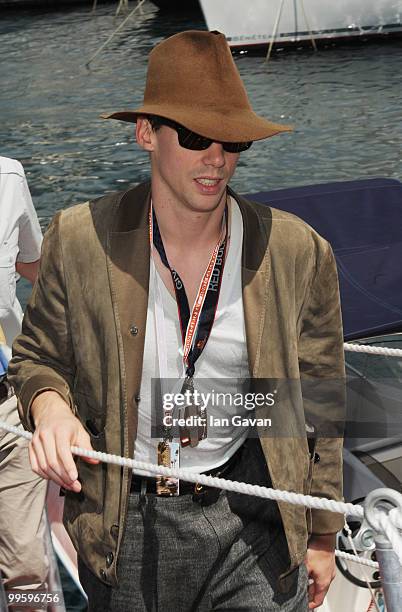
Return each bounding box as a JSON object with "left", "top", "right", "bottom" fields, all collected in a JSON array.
[{"left": 11, "top": 31, "right": 343, "bottom": 611}]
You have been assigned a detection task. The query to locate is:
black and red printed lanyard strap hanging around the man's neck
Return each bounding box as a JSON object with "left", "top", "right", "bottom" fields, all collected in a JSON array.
[{"left": 149, "top": 206, "right": 228, "bottom": 376}]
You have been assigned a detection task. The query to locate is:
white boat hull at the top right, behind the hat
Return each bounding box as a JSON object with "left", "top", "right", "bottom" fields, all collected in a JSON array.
[{"left": 200, "top": 0, "right": 402, "bottom": 49}]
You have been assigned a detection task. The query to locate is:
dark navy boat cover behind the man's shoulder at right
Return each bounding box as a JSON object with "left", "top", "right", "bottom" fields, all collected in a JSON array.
[{"left": 246, "top": 179, "right": 402, "bottom": 340}]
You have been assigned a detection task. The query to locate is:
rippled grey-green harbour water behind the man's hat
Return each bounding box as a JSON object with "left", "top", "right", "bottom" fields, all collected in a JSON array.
[{"left": 0, "top": 2, "right": 402, "bottom": 296}]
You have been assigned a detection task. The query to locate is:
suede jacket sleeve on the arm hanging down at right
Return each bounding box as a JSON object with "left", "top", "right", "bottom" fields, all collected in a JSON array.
[{"left": 299, "top": 237, "right": 345, "bottom": 534}]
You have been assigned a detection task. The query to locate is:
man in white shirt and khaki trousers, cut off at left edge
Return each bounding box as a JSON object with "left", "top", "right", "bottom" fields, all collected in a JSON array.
[{"left": 0, "top": 157, "right": 49, "bottom": 590}]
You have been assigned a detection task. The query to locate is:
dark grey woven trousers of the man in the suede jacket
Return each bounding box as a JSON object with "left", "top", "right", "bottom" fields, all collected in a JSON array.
[{"left": 79, "top": 439, "right": 307, "bottom": 612}]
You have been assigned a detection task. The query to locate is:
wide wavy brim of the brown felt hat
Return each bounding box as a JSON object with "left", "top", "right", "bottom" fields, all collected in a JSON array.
[{"left": 101, "top": 104, "right": 293, "bottom": 142}]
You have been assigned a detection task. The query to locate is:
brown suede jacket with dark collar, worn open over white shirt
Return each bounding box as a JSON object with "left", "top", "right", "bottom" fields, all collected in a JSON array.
[{"left": 9, "top": 183, "right": 344, "bottom": 590}]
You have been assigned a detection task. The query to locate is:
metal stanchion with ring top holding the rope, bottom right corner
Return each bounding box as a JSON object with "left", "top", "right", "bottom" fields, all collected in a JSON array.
[{"left": 364, "top": 489, "right": 402, "bottom": 612}]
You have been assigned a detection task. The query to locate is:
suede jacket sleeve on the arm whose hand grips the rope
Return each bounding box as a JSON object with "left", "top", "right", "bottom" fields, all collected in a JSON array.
[{"left": 8, "top": 213, "right": 75, "bottom": 431}]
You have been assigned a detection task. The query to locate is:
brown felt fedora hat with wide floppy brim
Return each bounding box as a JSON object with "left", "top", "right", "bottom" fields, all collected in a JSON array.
[{"left": 102, "top": 30, "right": 293, "bottom": 142}]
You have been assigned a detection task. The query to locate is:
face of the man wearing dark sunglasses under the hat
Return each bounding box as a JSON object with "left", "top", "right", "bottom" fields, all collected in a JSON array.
[{"left": 137, "top": 119, "right": 239, "bottom": 212}]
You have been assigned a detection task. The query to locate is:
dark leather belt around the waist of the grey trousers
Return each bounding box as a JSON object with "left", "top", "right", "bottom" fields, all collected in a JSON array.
[{"left": 130, "top": 446, "right": 243, "bottom": 501}]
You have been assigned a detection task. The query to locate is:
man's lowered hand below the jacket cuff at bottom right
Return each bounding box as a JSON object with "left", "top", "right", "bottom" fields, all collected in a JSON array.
[{"left": 304, "top": 534, "right": 336, "bottom": 610}]
